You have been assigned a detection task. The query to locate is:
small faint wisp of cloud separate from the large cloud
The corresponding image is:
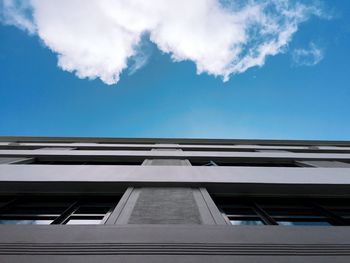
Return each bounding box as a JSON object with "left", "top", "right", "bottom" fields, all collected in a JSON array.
[{"left": 292, "top": 42, "right": 324, "bottom": 66}]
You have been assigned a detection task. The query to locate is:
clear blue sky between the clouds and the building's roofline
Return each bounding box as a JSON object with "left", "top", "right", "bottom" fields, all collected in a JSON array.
[{"left": 0, "top": 0, "right": 350, "bottom": 140}]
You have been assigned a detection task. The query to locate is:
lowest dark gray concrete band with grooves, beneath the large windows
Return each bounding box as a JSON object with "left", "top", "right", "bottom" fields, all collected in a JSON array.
[{"left": 0, "top": 225, "right": 350, "bottom": 263}]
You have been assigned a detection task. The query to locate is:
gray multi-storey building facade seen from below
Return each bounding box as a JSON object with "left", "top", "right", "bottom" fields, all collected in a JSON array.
[{"left": 0, "top": 137, "right": 350, "bottom": 263}]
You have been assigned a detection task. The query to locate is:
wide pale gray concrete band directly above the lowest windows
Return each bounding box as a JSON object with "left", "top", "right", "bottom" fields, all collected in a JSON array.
[{"left": 0, "top": 164, "right": 350, "bottom": 185}]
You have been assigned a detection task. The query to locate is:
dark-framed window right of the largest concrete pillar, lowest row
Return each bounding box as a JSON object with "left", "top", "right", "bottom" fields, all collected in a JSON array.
[{"left": 213, "top": 196, "right": 350, "bottom": 226}]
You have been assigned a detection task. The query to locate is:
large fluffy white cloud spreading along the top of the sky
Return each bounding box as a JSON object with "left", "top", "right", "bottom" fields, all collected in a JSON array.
[{"left": 2, "top": 0, "right": 322, "bottom": 84}]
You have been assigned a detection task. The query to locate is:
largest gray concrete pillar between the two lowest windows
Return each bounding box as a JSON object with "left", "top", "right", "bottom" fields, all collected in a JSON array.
[{"left": 112, "top": 187, "right": 226, "bottom": 225}]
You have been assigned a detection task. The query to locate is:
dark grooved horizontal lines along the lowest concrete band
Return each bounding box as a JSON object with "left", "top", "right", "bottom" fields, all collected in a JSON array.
[{"left": 0, "top": 243, "right": 350, "bottom": 256}]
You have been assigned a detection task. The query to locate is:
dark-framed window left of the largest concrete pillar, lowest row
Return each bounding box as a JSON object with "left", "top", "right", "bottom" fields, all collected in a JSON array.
[{"left": 0, "top": 196, "right": 120, "bottom": 225}]
